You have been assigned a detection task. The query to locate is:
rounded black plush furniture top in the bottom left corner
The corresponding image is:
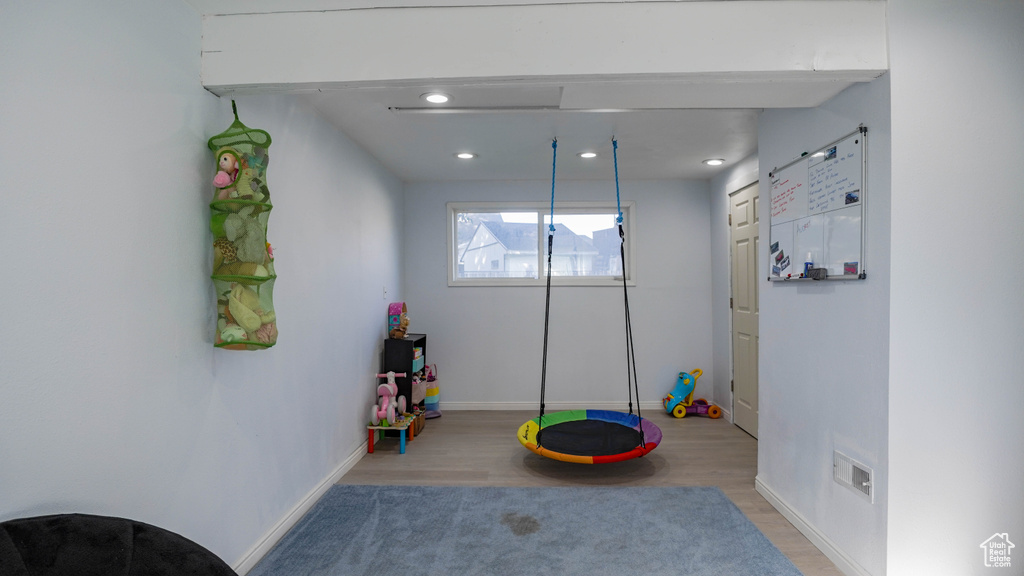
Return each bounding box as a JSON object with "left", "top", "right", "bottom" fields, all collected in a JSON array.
[{"left": 0, "top": 513, "right": 238, "bottom": 576}]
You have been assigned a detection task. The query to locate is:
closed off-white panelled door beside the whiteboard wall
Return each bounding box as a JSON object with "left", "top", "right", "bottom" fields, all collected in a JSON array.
[{"left": 729, "top": 182, "right": 760, "bottom": 438}]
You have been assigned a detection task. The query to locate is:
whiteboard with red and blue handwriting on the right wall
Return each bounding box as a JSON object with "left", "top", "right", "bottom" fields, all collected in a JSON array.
[{"left": 768, "top": 126, "right": 867, "bottom": 281}]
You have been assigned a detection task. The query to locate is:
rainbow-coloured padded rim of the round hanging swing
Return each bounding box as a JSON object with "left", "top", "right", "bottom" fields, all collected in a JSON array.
[{"left": 516, "top": 410, "right": 662, "bottom": 464}]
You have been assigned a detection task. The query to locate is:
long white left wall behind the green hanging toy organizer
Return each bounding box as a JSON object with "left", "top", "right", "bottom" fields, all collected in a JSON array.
[{"left": 0, "top": 1, "right": 402, "bottom": 565}]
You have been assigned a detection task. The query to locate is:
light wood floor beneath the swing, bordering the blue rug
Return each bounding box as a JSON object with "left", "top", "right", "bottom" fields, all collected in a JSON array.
[{"left": 339, "top": 410, "right": 842, "bottom": 576}]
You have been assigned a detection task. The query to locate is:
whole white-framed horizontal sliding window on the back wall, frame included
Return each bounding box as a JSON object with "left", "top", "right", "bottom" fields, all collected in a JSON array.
[{"left": 447, "top": 202, "right": 634, "bottom": 286}]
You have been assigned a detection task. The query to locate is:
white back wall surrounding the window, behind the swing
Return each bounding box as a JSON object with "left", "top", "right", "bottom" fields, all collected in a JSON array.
[{"left": 404, "top": 179, "right": 714, "bottom": 410}]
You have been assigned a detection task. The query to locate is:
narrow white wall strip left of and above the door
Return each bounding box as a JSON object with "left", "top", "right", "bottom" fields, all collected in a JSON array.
[{"left": 709, "top": 153, "right": 758, "bottom": 415}]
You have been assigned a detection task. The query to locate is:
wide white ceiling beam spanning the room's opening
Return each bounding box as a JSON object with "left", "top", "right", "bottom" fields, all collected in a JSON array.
[{"left": 202, "top": 0, "right": 889, "bottom": 96}]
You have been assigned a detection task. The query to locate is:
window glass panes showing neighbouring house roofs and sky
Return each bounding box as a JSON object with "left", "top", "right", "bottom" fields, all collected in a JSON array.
[{"left": 454, "top": 209, "right": 623, "bottom": 279}]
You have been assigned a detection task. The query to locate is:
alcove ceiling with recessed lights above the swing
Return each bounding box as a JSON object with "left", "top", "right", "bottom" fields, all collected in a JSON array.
[{"left": 301, "top": 84, "right": 758, "bottom": 181}]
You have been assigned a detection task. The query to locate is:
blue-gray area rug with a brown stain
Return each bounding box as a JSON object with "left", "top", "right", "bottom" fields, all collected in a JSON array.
[{"left": 249, "top": 485, "right": 800, "bottom": 576}]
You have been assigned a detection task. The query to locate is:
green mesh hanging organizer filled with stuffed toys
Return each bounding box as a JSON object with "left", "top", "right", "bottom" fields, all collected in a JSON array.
[{"left": 207, "top": 100, "right": 278, "bottom": 349}]
